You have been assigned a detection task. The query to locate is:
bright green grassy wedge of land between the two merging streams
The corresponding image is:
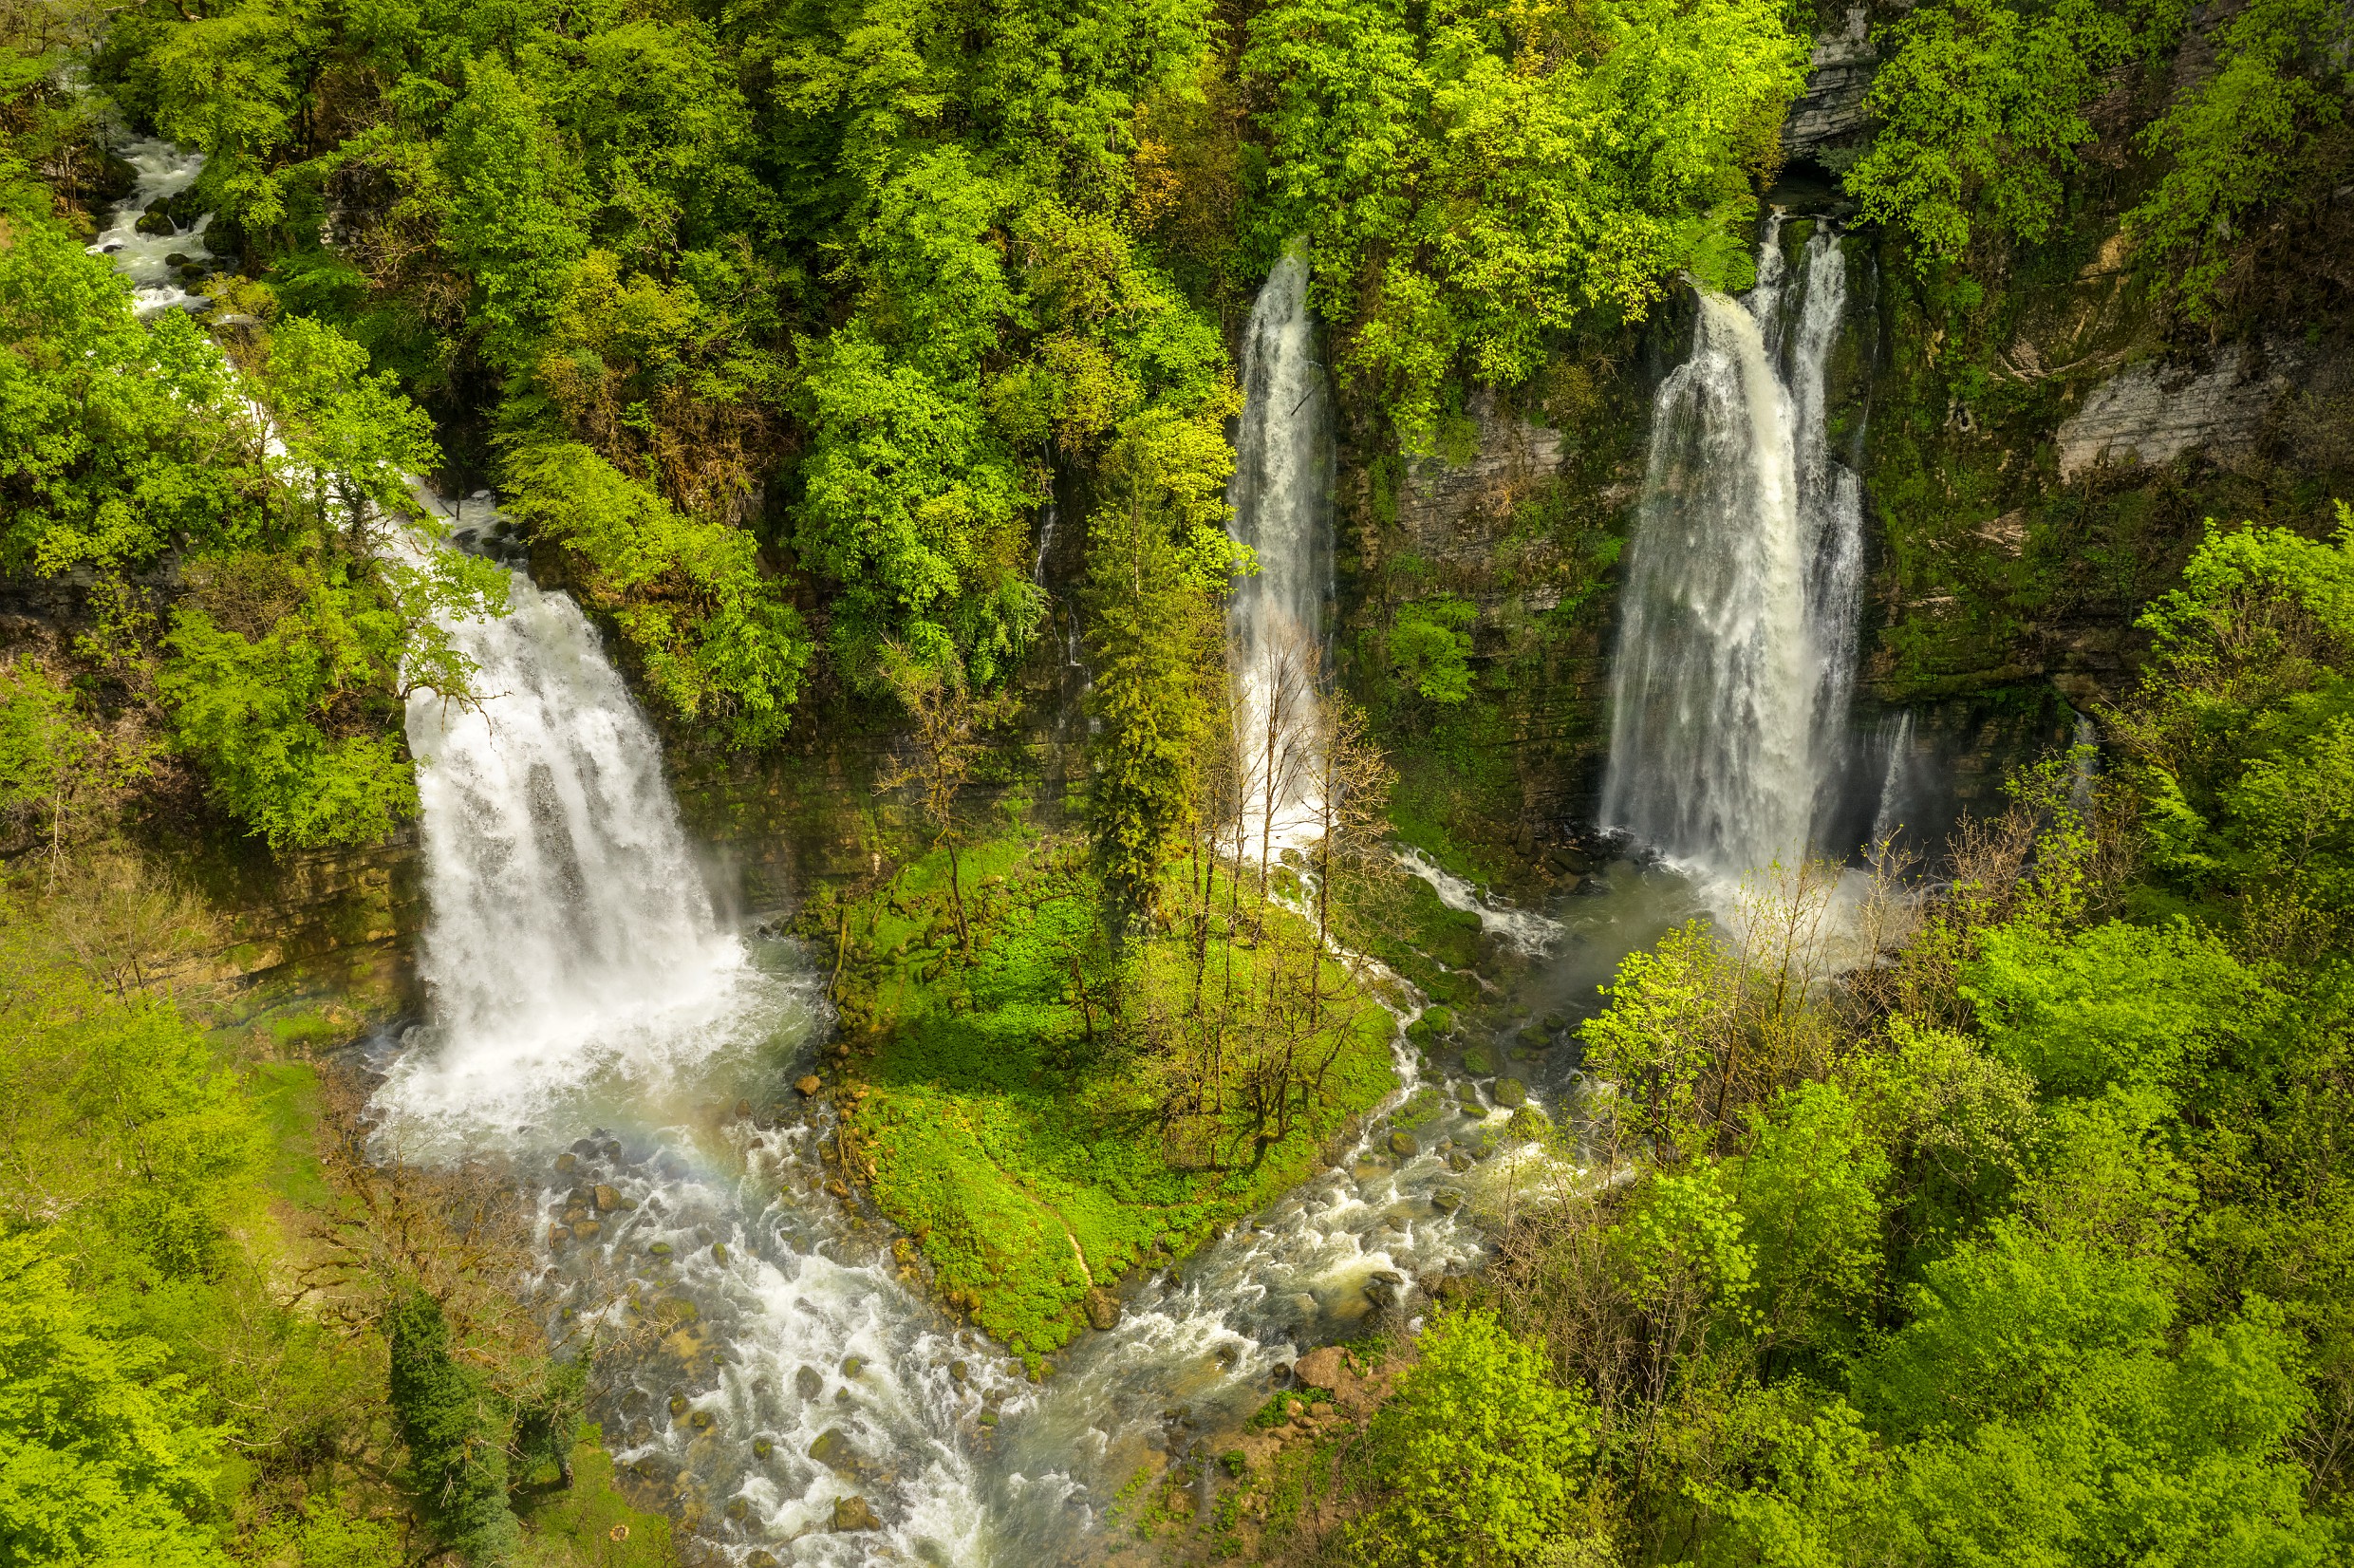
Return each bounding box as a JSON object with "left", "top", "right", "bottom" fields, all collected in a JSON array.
[{"left": 808, "top": 831, "right": 1393, "bottom": 1356}]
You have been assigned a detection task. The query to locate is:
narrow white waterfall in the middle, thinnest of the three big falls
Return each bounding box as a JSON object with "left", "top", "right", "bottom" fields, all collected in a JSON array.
[{"left": 1226, "top": 250, "right": 1333, "bottom": 857}]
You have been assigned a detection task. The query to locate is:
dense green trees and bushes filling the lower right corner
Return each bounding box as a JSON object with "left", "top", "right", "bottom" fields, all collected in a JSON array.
[{"left": 1233, "top": 528, "right": 2354, "bottom": 1566}]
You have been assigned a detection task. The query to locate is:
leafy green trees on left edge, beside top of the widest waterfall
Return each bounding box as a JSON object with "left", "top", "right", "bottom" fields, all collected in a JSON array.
[{"left": 0, "top": 224, "right": 504, "bottom": 848}]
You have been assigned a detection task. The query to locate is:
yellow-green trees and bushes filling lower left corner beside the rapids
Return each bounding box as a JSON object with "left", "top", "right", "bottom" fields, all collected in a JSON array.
[{"left": 0, "top": 870, "right": 662, "bottom": 1568}]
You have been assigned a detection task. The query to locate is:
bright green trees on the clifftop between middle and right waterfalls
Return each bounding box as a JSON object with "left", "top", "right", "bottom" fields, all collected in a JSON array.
[{"left": 1241, "top": 0, "right": 1805, "bottom": 450}]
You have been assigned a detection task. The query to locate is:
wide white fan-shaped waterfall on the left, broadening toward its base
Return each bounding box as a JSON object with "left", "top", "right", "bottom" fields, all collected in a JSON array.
[{"left": 376, "top": 572, "right": 758, "bottom": 1123}]
